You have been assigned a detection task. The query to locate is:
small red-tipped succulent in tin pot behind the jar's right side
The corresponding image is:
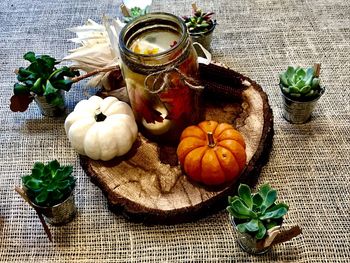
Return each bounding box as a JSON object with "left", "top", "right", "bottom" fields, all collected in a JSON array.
[{"left": 183, "top": 4, "right": 216, "bottom": 55}]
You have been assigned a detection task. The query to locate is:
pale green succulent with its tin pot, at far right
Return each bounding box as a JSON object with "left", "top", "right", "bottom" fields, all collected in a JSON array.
[{"left": 279, "top": 64, "right": 325, "bottom": 123}]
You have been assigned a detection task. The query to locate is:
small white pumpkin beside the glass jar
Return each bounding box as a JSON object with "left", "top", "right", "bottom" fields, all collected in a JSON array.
[{"left": 64, "top": 96, "right": 137, "bottom": 161}]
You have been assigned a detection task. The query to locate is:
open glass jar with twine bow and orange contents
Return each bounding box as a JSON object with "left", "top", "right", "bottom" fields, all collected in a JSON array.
[{"left": 119, "top": 13, "right": 203, "bottom": 143}]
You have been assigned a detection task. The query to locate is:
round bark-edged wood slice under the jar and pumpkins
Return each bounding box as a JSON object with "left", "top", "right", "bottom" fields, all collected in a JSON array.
[{"left": 81, "top": 63, "right": 273, "bottom": 224}]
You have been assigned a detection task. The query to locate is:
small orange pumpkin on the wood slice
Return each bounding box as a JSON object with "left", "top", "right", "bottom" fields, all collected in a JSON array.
[{"left": 177, "top": 121, "right": 246, "bottom": 185}]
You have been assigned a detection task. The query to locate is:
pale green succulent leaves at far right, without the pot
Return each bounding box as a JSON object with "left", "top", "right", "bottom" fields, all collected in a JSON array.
[{"left": 279, "top": 66, "right": 323, "bottom": 101}]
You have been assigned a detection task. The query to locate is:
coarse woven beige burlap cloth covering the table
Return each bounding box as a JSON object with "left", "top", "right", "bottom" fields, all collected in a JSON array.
[{"left": 0, "top": 0, "right": 350, "bottom": 262}]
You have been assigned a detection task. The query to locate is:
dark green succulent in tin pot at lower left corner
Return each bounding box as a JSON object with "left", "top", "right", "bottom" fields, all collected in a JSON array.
[{"left": 22, "top": 160, "right": 76, "bottom": 225}]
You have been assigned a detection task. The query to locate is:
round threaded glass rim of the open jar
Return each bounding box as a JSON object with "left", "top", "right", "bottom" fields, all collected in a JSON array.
[{"left": 119, "top": 12, "right": 188, "bottom": 58}]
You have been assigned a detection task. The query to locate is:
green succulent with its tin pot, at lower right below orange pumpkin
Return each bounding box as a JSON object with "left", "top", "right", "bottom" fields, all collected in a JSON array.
[{"left": 226, "top": 184, "right": 288, "bottom": 254}]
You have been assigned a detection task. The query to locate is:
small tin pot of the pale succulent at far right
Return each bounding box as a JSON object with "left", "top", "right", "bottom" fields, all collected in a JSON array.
[{"left": 281, "top": 87, "right": 325, "bottom": 124}]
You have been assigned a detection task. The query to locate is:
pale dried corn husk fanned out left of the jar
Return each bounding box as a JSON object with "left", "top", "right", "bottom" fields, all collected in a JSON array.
[{"left": 63, "top": 17, "right": 124, "bottom": 90}]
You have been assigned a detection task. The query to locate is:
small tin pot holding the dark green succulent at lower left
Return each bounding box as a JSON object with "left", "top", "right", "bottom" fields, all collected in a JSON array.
[{"left": 32, "top": 193, "right": 77, "bottom": 226}]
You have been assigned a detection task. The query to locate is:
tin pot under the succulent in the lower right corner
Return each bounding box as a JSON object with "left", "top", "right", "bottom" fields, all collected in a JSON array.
[{"left": 230, "top": 216, "right": 272, "bottom": 255}]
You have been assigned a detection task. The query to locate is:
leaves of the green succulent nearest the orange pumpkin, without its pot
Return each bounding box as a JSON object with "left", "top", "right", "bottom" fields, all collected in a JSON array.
[{"left": 226, "top": 184, "right": 288, "bottom": 239}]
